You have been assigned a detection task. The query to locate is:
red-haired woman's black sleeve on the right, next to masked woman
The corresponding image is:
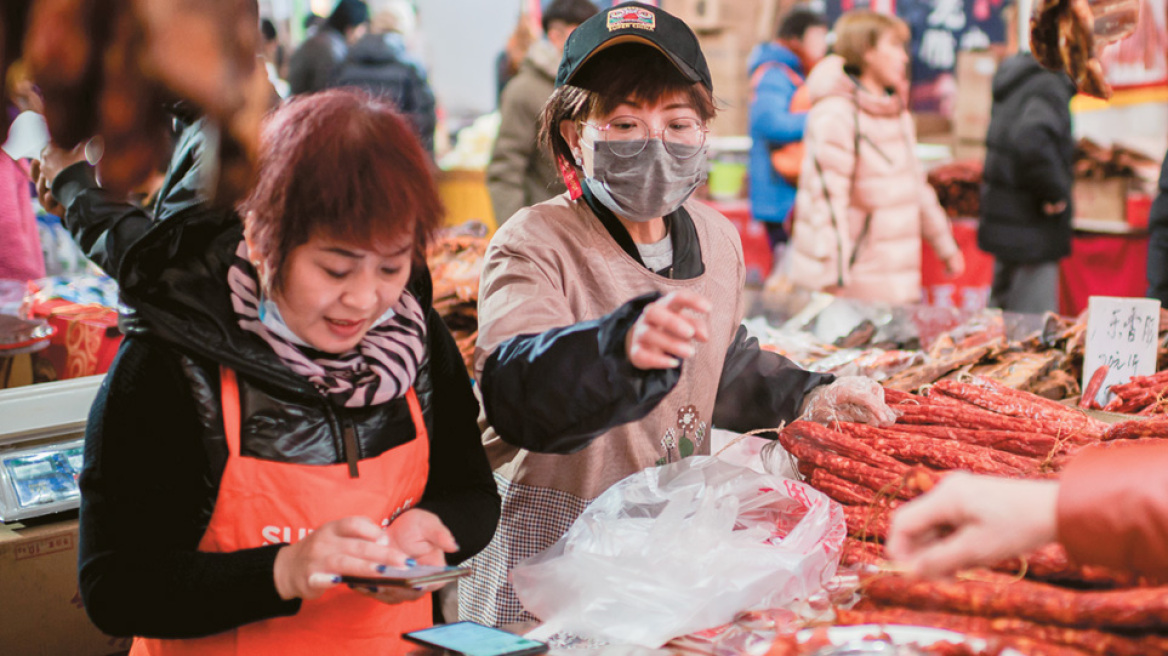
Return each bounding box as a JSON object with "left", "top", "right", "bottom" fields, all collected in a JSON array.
[{"left": 418, "top": 310, "right": 499, "bottom": 564}]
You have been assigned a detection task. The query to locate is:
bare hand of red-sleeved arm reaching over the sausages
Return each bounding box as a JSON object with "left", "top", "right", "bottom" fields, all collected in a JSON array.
[{"left": 888, "top": 473, "right": 1058, "bottom": 577}]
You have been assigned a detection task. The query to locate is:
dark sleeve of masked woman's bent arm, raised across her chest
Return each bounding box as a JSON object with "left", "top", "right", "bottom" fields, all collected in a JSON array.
[{"left": 480, "top": 294, "right": 681, "bottom": 453}]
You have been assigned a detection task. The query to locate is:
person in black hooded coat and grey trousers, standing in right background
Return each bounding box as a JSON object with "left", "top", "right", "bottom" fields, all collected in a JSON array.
[{"left": 978, "top": 53, "right": 1075, "bottom": 313}]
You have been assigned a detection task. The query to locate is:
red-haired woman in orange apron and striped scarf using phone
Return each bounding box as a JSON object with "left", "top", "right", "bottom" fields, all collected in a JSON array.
[{"left": 38, "top": 91, "right": 499, "bottom": 654}]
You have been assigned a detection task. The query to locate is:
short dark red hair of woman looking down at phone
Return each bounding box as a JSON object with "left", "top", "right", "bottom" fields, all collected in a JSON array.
[{"left": 239, "top": 89, "right": 443, "bottom": 287}]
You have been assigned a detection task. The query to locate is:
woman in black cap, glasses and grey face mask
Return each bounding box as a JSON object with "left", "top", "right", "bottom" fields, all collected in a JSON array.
[{"left": 459, "top": 4, "right": 890, "bottom": 624}]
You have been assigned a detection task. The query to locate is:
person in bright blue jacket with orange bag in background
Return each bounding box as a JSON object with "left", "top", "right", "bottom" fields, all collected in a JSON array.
[{"left": 749, "top": 7, "right": 828, "bottom": 247}]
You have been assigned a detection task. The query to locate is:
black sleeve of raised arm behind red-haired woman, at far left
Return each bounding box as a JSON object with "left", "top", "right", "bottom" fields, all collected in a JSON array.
[{"left": 51, "top": 162, "right": 154, "bottom": 279}]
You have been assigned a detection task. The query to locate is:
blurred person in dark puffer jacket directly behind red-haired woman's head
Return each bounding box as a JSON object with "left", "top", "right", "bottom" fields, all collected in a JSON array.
[{"left": 329, "top": 3, "right": 438, "bottom": 156}]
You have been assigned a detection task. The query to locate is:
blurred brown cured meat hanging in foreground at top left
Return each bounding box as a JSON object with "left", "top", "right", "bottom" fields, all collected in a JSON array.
[{"left": 23, "top": 0, "right": 273, "bottom": 203}]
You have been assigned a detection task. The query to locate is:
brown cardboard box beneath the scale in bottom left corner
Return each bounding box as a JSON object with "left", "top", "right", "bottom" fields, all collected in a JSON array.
[{"left": 0, "top": 519, "right": 130, "bottom": 656}]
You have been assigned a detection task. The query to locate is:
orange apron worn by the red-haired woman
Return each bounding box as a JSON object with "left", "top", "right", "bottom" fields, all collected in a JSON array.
[{"left": 130, "top": 368, "right": 433, "bottom": 656}]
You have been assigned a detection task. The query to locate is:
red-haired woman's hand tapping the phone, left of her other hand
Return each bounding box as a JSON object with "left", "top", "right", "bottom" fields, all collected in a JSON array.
[{"left": 273, "top": 517, "right": 409, "bottom": 600}]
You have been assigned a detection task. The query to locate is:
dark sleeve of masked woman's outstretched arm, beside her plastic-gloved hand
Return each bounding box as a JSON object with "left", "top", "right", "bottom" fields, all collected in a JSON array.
[{"left": 714, "top": 326, "right": 835, "bottom": 433}]
